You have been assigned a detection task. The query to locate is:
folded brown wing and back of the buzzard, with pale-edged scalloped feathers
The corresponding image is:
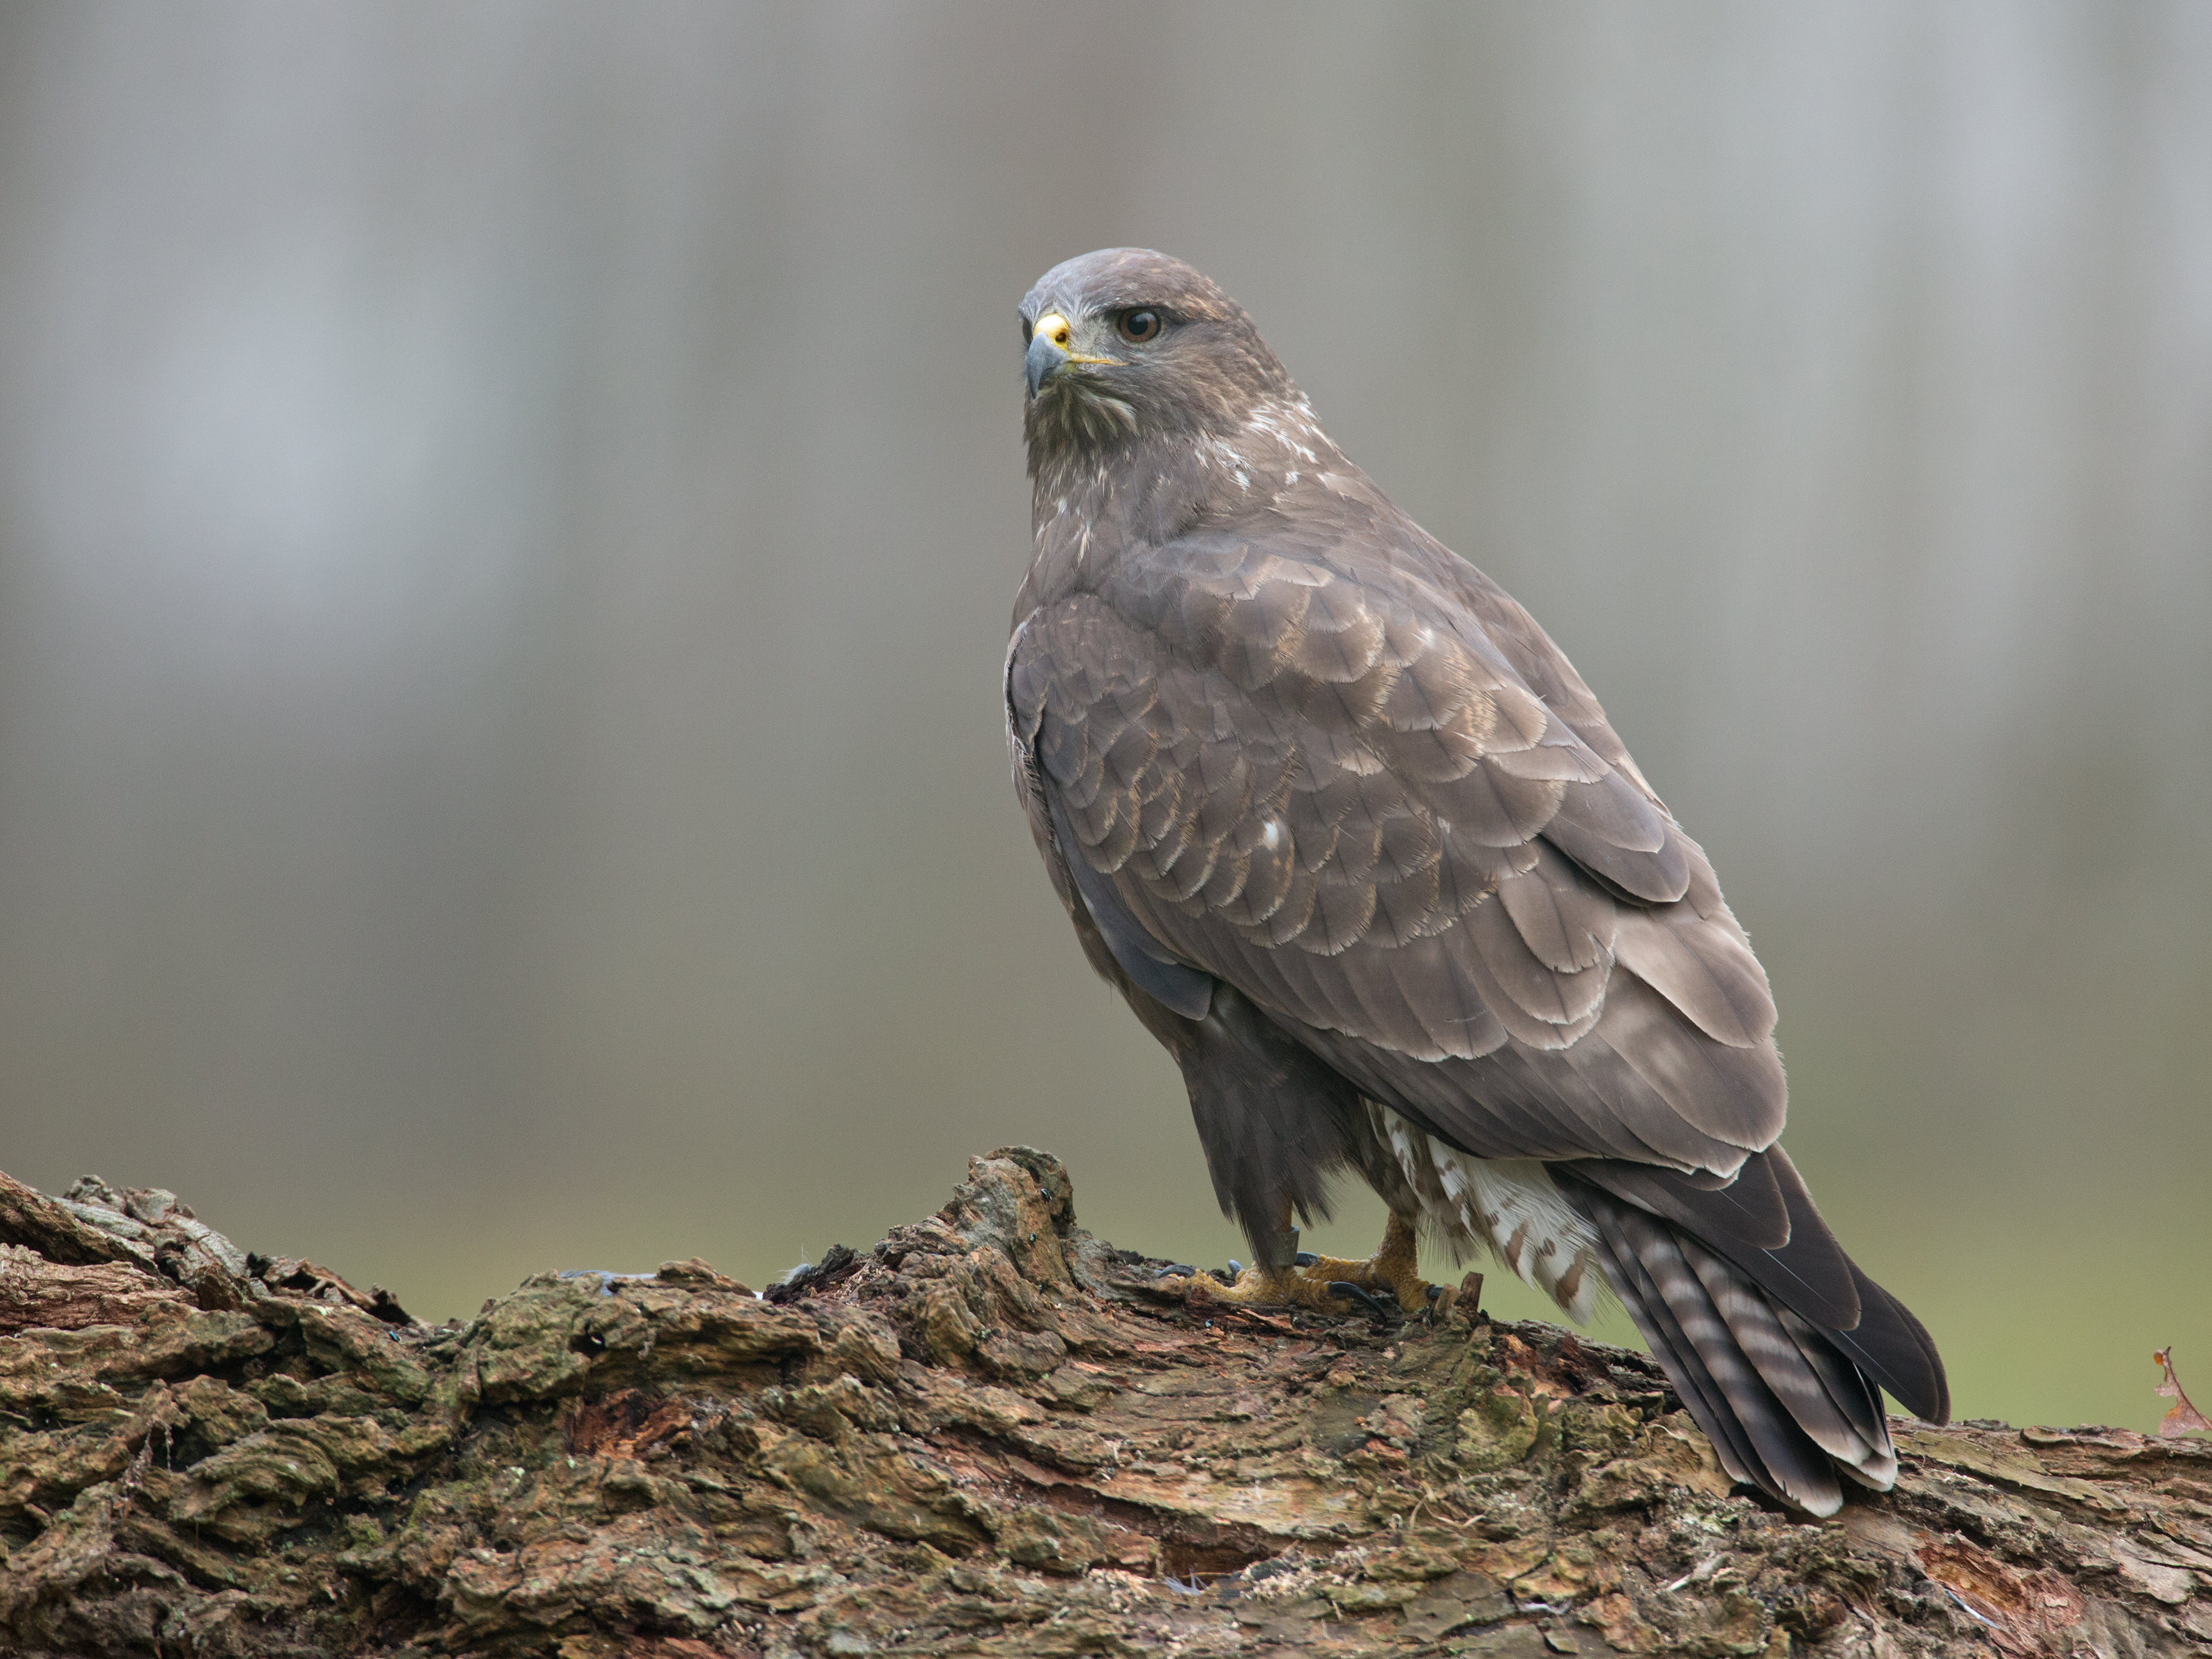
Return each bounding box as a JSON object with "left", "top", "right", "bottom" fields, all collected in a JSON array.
[{"left": 1006, "top": 515, "right": 1785, "bottom": 1175}]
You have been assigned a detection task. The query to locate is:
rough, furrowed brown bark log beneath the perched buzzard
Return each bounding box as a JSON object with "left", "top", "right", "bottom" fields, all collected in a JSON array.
[{"left": 0, "top": 1148, "right": 2212, "bottom": 1659}]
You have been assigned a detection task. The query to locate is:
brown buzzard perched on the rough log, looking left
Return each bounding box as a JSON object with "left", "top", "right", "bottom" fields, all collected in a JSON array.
[{"left": 1004, "top": 248, "right": 1949, "bottom": 1515}]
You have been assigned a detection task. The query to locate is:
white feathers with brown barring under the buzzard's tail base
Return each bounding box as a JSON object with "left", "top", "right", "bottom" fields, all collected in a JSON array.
[{"left": 1367, "top": 1102, "right": 1606, "bottom": 1323}]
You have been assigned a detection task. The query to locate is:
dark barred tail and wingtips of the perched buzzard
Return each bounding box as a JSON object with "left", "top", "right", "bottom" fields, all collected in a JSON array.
[{"left": 1553, "top": 1146, "right": 1951, "bottom": 1515}]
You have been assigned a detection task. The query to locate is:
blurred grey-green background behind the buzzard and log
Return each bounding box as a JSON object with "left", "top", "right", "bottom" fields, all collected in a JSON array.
[{"left": 0, "top": 0, "right": 2212, "bottom": 1427}]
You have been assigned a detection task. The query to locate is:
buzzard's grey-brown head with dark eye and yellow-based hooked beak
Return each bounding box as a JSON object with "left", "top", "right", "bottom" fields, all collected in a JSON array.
[{"left": 1022, "top": 248, "right": 1296, "bottom": 465}]
